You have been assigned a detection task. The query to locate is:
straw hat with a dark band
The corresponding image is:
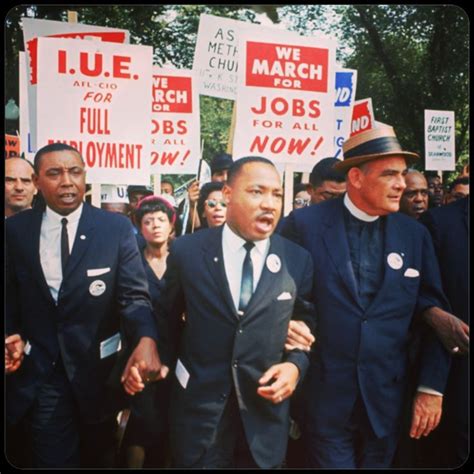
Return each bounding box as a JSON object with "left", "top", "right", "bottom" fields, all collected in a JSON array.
[{"left": 334, "top": 122, "right": 420, "bottom": 171}]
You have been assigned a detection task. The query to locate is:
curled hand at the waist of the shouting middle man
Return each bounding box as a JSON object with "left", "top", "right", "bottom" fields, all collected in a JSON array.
[{"left": 257, "top": 362, "right": 300, "bottom": 403}]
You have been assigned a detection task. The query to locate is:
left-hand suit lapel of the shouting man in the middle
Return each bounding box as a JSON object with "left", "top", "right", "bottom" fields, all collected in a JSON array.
[{"left": 203, "top": 226, "right": 239, "bottom": 319}]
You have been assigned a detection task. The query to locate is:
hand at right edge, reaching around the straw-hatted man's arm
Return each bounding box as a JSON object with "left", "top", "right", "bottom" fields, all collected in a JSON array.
[{"left": 423, "top": 306, "right": 469, "bottom": 355}]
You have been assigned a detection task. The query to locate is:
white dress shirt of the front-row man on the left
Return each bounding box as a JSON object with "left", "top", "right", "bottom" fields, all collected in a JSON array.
[{"left": 40, "top": 203, "right": 83, "bottom": 302}]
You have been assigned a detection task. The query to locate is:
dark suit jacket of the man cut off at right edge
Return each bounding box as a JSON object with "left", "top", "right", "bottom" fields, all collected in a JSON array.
[{"left": 420, "top": 198, "right": 469, "bottom": 426}]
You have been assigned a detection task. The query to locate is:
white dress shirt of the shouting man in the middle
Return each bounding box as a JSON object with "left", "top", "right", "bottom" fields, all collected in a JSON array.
[{"left": 222, "top": 224, "right": 270, "bottom": 310}]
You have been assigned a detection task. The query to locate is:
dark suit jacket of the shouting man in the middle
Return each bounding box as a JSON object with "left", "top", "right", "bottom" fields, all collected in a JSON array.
[{"left": 160, "top": 227, "right": 314, "bottom": 468}]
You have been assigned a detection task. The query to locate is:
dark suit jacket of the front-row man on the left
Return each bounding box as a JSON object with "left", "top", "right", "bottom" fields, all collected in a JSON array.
[{"left": 6, "top": 203, "right": 157, "bottom": 422}]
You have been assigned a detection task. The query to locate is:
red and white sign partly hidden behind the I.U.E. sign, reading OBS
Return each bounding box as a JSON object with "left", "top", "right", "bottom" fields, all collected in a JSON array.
[{"left": 151, "top": 67, "right": 200, "bottom": 174}]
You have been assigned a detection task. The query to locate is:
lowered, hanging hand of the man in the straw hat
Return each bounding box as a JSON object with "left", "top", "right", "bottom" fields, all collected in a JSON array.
[{"left": 410, "top": 392, "right": 443, "bottom": 439}]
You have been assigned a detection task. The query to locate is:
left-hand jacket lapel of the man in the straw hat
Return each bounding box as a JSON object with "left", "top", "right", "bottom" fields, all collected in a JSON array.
[{"left": 323, "top": 199, "right": 360, "bottom": 306}]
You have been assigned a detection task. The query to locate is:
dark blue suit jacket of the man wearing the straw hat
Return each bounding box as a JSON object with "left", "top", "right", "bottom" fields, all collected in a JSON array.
[{"left": 283, "top": 198, "right": 449, "bottom": 437}]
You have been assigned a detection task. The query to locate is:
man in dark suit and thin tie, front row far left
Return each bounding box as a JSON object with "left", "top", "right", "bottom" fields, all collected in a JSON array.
[{"left": 5, "top": 143, "right": 166, "bottom": 468}]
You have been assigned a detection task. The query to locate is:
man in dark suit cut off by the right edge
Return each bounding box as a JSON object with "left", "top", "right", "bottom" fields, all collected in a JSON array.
[{"left": 419, "top": 197, "right": 469, "bottom": 468}]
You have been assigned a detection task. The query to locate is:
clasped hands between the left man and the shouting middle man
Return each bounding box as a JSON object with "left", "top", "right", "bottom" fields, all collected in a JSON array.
[{"left": 121, "top": 337, "right": 169, "bottom": 395}]
